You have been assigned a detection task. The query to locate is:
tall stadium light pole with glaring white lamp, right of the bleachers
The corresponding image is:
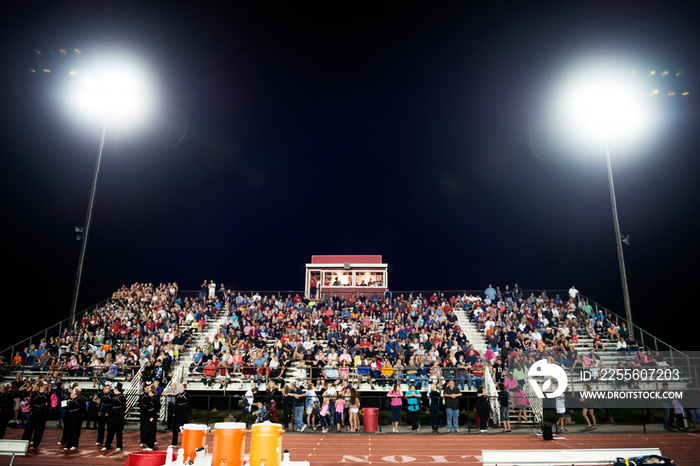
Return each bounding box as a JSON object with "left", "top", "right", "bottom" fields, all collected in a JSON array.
[{"left": 562, "top": 70, "right": 648, "bottom": 338}]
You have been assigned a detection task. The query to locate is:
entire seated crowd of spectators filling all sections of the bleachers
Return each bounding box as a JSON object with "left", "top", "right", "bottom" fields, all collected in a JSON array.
[{"left": 4, "top": 281, "right": 654, "bottom": 400}]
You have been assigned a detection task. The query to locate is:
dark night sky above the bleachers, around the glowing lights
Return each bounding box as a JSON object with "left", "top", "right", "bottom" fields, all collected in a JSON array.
[{"left": 0, "top": 1, "right": 700, "bottom": 349}]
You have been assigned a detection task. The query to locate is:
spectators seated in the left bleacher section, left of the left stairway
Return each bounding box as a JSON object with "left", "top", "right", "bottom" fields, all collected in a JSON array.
[{"left": 0, "top": 283, "right": 221, "bottom": 388}]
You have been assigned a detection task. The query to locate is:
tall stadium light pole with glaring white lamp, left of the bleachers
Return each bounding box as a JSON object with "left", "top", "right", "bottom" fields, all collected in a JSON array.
[{"left": 68, "top": 60, "right": 152, "bottom": 326}]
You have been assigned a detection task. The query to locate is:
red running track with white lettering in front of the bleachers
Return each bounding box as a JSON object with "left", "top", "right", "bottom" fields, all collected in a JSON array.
[{"left": 0, "top": 429, "right": 700, "bottom": 466}]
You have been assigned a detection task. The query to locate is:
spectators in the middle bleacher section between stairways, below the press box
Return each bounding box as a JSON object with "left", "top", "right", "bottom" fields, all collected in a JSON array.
[{"left": 190, "top": 291, "right": 484, "bottom": 389}]
